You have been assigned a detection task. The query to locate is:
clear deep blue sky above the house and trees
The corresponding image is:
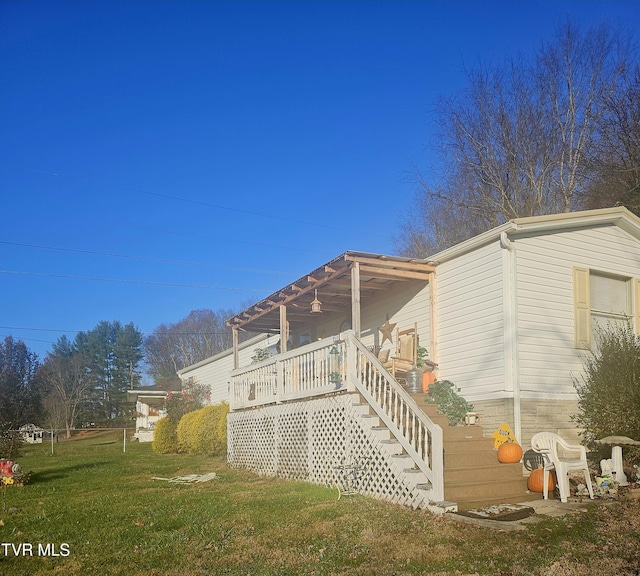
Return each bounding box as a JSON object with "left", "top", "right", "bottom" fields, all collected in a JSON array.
[{"left": 0, "top": 0, "right": 640, "bottom": 358}]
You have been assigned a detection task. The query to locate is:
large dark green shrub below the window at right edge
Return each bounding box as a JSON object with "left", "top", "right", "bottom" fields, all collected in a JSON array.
[{"left": 573, "top": 326, "right": 640, "bottom": 462}]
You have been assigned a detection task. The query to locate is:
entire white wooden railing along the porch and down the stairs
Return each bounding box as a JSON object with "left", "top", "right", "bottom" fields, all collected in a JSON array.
[{"left": 230, "top": 331, "right": 444, "bottom": 501}]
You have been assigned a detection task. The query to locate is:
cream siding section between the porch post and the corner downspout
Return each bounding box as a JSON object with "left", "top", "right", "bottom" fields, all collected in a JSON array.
[{"left": 436, "top": 240, "right": 505, "bottom": 402}]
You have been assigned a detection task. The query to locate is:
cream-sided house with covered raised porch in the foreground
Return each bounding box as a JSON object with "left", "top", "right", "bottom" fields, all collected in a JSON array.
[{"left": 180, "top": 208, "right": 640, "bottom": 505}]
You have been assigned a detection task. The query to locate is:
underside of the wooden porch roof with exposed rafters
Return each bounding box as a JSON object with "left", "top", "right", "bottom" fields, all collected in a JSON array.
[{"left": 227, "top": 251, "right": 435, "bottom": 332}]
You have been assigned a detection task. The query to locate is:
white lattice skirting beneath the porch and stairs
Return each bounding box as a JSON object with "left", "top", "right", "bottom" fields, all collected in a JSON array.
[{"left": 228, "top": 393, "right": 429, "bottom": 508}]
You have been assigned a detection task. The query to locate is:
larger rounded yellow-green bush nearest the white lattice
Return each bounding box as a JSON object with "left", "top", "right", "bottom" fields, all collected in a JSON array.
[{"left": 177, "top": 402, "right": 229, "bottom": 456}]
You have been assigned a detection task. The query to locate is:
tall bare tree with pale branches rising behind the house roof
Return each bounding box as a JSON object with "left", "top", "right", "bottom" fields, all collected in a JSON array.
[{"left": 396, "top": 23, "right": 631, "bottom": 256}]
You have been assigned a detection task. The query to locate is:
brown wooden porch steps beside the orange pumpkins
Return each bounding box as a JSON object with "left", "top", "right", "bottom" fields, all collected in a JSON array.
[{"left": 411, "top": 394, "right": 542, "bottom": 510}]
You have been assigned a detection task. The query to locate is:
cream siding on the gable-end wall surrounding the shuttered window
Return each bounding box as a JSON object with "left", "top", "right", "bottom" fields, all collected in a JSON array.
[{"left": 514, "top": 226, "right": 640, "bottom": 399}]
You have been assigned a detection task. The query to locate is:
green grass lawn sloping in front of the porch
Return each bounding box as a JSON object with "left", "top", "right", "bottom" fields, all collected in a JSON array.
[{"left": 0, "top": 431, "right": 640, "bottom": 576}]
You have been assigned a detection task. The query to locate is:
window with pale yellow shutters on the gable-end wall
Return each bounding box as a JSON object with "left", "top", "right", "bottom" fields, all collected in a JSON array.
[{"left": 573, "top": 268, "right": 640, "bottom": 349}]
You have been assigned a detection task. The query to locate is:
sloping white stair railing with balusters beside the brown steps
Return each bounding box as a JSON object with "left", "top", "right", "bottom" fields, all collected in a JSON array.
[{"left": 343, "top": 331, "right": 444, "bottom": 502}]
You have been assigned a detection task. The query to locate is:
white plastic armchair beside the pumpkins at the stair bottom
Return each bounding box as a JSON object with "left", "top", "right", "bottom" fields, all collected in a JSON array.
[{"left": 531, "top": 432, "right": 593, "bottom": 502}]
